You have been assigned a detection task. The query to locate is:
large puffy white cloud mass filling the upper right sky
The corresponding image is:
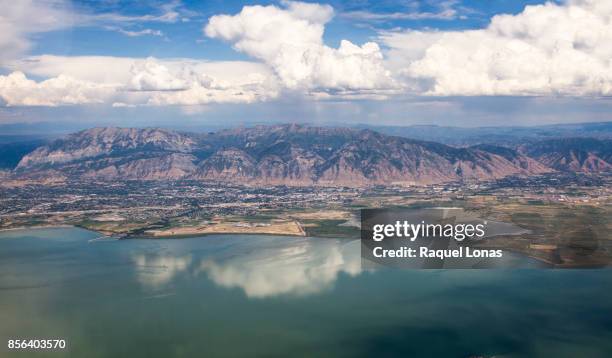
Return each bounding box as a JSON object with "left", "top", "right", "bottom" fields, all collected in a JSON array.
[{"left": 381, "top": 0, "right": 612, "bottom": 96}]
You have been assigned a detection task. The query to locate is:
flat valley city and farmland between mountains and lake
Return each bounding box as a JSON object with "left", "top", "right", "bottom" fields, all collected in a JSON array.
[{"left": 0, "top": 173, "right": 612, "bottom": 267}]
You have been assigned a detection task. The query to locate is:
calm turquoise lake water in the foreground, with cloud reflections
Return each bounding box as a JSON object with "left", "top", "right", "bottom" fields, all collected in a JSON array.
[{"left": 0, "top": 228, "right": 612, "bottom": 358}]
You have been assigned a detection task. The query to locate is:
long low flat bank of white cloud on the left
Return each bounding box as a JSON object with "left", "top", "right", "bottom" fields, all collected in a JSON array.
[{"left": 0, "top": 55, "right": 279, "bottom": 106}]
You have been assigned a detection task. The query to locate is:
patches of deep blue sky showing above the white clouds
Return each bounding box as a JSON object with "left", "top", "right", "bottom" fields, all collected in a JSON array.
[{"left": 31, "top": 0, "right": 544, "bottom": 60}]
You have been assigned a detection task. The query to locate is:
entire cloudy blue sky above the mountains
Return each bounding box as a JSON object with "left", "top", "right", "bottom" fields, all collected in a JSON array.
[{"left": 0, "top": 0, "right": 612, "bottom": 128}]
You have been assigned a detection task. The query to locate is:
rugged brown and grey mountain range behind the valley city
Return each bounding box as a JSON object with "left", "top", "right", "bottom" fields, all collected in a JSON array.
[{"left": 9, "top": 124, "right": 612, "bottom": 186}]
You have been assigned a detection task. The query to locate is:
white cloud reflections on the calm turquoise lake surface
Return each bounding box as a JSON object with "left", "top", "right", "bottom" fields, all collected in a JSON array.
[{"left": 132, "top": 237, "right": 361, "bottom": 298}]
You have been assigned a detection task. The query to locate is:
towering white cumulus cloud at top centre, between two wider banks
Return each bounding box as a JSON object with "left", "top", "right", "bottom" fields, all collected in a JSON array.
[{"left": 204, "top": 1, "right": 394, "bottom": 91}]
